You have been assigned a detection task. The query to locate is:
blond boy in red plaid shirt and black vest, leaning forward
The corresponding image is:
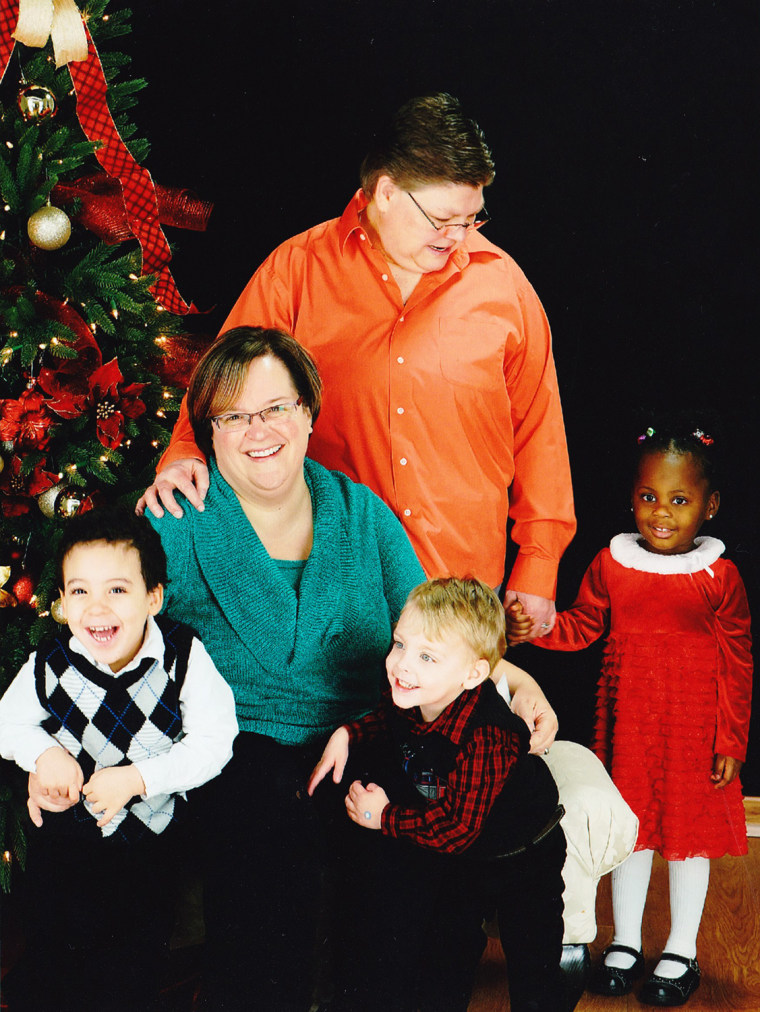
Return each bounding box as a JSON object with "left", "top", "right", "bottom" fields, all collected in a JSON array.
[{"left": 309, "top": 579, "right": 566, "bottom": 1012}]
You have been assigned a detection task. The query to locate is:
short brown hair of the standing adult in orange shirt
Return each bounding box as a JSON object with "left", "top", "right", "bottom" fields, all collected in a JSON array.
[{"left": 359, "top": 92, "right": 494, "bottom": 199}]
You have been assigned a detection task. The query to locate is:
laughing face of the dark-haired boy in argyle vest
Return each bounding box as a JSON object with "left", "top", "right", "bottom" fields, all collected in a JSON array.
[{"left": 61, "top": 541, "right": 164, "bottom": 671}]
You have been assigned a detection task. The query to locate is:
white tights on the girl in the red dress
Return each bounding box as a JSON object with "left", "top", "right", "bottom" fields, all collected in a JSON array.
[{"left": 604, "top": 850, "right": 709, "bottom": 978}]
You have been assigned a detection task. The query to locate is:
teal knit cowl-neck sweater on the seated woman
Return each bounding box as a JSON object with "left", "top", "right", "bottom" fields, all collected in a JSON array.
[{"left": 150, "top": 459, "right": 424, "bottom": 745}]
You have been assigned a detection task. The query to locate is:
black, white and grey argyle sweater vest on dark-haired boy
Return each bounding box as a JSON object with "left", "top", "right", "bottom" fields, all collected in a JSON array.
[{"left": 34, "top": 615, "right": 195, "bottom": 843}]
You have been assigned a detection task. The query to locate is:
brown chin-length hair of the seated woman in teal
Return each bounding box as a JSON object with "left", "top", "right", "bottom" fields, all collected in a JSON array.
[{"left": 187, "top": 327, "right": 322, "bottom": 456}]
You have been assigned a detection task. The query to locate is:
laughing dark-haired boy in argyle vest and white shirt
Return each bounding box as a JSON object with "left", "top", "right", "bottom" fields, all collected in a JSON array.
[{"left": 0, "top": 508, "right": 237, "bottom": 1012}]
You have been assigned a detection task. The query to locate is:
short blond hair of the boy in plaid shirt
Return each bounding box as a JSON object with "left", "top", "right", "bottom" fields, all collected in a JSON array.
[{"left": 404, "top": 577, "right": 507, "bottom": 671}]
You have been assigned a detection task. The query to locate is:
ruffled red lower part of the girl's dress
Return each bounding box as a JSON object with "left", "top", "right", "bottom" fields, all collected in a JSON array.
[{"left": 593, "top": 635, "right": 747, "bottom": 860}]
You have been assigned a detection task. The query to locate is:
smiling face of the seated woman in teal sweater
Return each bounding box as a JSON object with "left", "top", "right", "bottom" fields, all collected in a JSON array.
[{"left": 213, "top": 355, "right": 312, "bottom": 503}]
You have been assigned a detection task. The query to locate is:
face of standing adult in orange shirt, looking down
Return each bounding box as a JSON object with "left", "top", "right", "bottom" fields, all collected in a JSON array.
[{"left": 367, "top": 176, "right": 483, "bottom": 274}]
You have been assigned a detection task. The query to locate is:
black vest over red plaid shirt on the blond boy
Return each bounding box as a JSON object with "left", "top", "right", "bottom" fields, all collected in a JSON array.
[{"left": 391, "top": 681, "right": 559, "bottom": 859}]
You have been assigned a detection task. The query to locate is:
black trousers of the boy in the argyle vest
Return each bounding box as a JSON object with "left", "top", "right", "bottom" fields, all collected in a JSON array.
[{"left": 8, "top": 806, "right": 181, "bottom": 1012}]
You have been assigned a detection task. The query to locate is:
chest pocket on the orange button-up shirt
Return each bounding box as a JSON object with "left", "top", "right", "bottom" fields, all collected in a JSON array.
[{"left": 436, "top": 319, "right": 507, "bottom": 392}]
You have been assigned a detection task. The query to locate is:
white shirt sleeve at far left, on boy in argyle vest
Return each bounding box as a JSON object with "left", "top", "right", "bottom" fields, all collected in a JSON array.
[{"left": 0, "top": 654, "right": 63, "bottom": 773}]
